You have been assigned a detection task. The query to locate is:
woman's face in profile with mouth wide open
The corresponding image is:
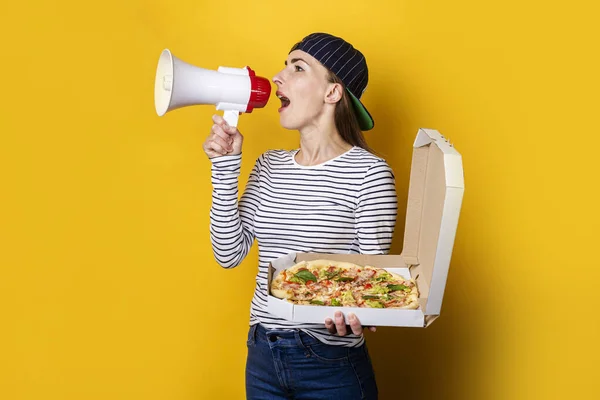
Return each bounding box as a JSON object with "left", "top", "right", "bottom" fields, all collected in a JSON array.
[{"left": 273, "top": 50, "right": 332, "bottom": 130}]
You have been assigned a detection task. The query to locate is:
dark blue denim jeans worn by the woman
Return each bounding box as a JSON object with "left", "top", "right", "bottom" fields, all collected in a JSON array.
[{"left": 246, "top": 324, "right": 377, "bottom": 400}]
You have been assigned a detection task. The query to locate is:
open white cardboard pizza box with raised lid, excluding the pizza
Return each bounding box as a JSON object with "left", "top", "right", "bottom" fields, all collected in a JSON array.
[{"left": 267, "top": 129, "right": 464, "bottom": 327}]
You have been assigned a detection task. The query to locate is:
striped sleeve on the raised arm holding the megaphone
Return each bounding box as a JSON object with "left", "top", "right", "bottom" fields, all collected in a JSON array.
[{"left": 210, "top": 154, "right": 260, "bottom": 268}]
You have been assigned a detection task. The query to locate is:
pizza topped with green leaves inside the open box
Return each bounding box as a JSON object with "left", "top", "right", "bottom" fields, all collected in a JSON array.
[{"left": 271, "top": 259, "right": 419, "bottom": 309}]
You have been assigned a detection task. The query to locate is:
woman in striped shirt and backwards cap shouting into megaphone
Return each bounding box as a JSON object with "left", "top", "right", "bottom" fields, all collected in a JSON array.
[{"left": 203, "top": 33, "right": 397, "bottom": 400}]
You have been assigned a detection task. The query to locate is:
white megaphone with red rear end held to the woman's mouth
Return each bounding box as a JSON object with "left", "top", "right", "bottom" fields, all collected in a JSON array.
[{"left": 154, "top": 49, "right": 271, "bottom": 126}]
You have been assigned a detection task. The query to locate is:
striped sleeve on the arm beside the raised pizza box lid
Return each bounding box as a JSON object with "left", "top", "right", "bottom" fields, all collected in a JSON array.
[{"left": 354, "top": 160, "right": 398, "bottom": 254}]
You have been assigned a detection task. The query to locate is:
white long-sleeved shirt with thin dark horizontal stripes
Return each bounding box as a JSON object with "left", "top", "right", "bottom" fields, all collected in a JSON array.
[{"left": 210, "top": 147, "right": 397, "bottom": 347}]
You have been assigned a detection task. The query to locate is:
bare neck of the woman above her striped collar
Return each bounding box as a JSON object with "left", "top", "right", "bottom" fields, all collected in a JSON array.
[{"left": 296, "top": 120, "right": 352, "bottom": 166}]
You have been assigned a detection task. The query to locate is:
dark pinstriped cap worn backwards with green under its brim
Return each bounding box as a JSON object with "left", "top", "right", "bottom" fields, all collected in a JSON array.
[{"left": 290, "top": 33, "right": 375, "bottom": 131}]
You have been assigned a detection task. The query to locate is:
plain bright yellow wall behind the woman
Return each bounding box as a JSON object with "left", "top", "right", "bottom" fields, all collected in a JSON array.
[{"left": 0, "top": 0, "right": 600, "bottom": 400}]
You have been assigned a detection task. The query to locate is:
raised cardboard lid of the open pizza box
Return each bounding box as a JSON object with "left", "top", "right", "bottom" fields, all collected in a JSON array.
[{"left": 402, "top": 129, "right": 465, "bottom": 315}]
